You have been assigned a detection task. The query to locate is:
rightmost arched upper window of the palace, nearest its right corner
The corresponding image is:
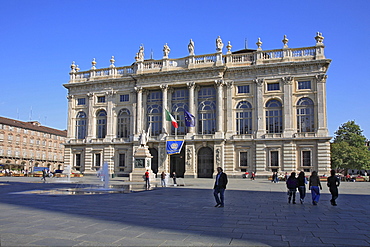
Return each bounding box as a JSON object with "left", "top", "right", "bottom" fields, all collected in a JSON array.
[{"left": 297, "top": 98, "right": 315, "bottom": 132}]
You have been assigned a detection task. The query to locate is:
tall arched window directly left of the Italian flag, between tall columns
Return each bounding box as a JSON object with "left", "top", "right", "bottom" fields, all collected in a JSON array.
[{"left": 147, "top": 91, "right": 162, "bottom": 136}]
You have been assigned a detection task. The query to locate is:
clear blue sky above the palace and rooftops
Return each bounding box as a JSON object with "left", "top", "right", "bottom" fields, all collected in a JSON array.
[{"left": 0, "top": 0, "right": 370, "bottom": 139}]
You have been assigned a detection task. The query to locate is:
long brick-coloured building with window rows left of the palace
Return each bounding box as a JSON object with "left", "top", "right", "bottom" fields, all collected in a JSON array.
[{"left": 0, "top": 117, "right": 67, "bottom": 171}]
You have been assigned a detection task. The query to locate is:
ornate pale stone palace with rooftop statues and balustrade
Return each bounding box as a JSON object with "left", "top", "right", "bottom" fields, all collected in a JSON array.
[{"left": 64, "top": 33, "right": 331, "bottom": 178}]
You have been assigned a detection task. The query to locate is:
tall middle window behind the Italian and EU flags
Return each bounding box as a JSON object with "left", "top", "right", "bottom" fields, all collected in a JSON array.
[{"left": 171, "top": 88, "right": 189, "bottom": 135}]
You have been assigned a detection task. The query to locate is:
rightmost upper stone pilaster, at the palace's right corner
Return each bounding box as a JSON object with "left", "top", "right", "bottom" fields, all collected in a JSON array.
[{"left": 315, "top": 74, "right": 328, "bottom": 137}]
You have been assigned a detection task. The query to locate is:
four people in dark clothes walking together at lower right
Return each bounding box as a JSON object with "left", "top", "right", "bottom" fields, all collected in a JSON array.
[{"left": 286, "top": 170, "right": 340, "bottom": 206}]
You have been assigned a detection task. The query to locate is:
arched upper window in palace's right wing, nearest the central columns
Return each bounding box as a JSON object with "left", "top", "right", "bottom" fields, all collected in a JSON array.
[{"left": 236, "top": 101, "right": 252, "bottom": 135}]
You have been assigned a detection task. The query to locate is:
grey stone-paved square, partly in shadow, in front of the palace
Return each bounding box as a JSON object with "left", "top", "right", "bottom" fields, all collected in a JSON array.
[{"left": 0, "top": 177, "right": 370, "bottom": 246}]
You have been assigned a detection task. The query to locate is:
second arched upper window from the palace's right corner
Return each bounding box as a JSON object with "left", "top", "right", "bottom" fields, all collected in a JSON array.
[{"left": 266, "top": 99, "right": 283, "bottom": 133}]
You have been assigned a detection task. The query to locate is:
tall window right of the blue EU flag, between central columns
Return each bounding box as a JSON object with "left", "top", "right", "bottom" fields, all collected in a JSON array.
[{"left": 198, "top": 87, "right": 216, "bottom": 134}]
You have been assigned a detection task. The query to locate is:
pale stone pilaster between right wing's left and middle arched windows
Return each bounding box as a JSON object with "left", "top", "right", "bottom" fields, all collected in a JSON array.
[{"left": 254, "top": 79, "right": 266, "bottom": 138}]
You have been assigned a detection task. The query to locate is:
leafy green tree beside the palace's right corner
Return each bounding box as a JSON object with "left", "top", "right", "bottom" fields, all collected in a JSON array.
[{"left": 330, "top": 121, "right": 370, "bottom": 170}]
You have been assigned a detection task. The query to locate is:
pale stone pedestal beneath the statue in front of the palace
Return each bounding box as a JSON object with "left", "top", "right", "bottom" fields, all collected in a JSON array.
[{"left": 130, "top": 145, "right": 153, "bottom": 181}]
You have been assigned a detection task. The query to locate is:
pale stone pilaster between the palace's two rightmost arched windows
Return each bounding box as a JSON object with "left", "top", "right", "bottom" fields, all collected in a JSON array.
[{"left": 282, "top": 76, "right": 295, "bottom": 138}]
